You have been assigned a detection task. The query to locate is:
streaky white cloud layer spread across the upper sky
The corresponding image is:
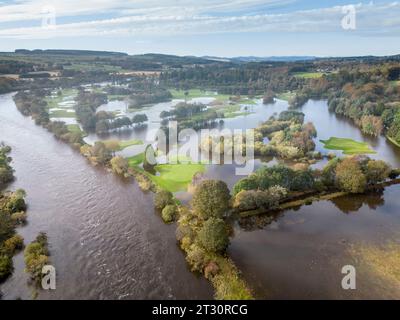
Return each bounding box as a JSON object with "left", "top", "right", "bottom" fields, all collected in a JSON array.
[{"left": 0, "top": 0, "right": 400, "bottom": 39}]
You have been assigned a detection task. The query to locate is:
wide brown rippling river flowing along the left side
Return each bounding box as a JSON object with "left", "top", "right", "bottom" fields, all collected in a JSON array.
[{"left": 0, "top": 94, "right": 213, "bottom": 299}]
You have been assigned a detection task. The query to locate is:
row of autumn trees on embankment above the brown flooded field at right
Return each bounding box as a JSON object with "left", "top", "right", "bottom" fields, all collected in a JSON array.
[{"left": 233, "top": 156, "right": 398, "bottom": 211}]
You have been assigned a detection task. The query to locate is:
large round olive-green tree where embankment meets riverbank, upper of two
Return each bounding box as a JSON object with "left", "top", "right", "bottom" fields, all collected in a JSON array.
[{"left": 192, "top": 180, "right": 230, "bottom": 220}]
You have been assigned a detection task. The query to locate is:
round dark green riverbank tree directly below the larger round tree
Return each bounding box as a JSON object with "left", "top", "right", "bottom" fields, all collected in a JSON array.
[{"left": 198, "top": 217, "right": 229, "bottom": 252}]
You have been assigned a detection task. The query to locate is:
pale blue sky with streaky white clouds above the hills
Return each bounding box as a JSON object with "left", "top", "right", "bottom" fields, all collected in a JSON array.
[{"left": 0, "top": 0, "right": 400, "bottom": 57}]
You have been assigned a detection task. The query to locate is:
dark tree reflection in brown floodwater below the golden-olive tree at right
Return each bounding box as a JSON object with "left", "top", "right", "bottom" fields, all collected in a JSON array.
[{"left": 331, "top": 190, "right": 385, "bottom": 214}]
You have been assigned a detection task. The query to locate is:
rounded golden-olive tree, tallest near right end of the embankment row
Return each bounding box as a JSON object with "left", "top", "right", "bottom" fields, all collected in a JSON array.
[{"left": 336, "top": 157, "right": 367, "bottom": 193}]
